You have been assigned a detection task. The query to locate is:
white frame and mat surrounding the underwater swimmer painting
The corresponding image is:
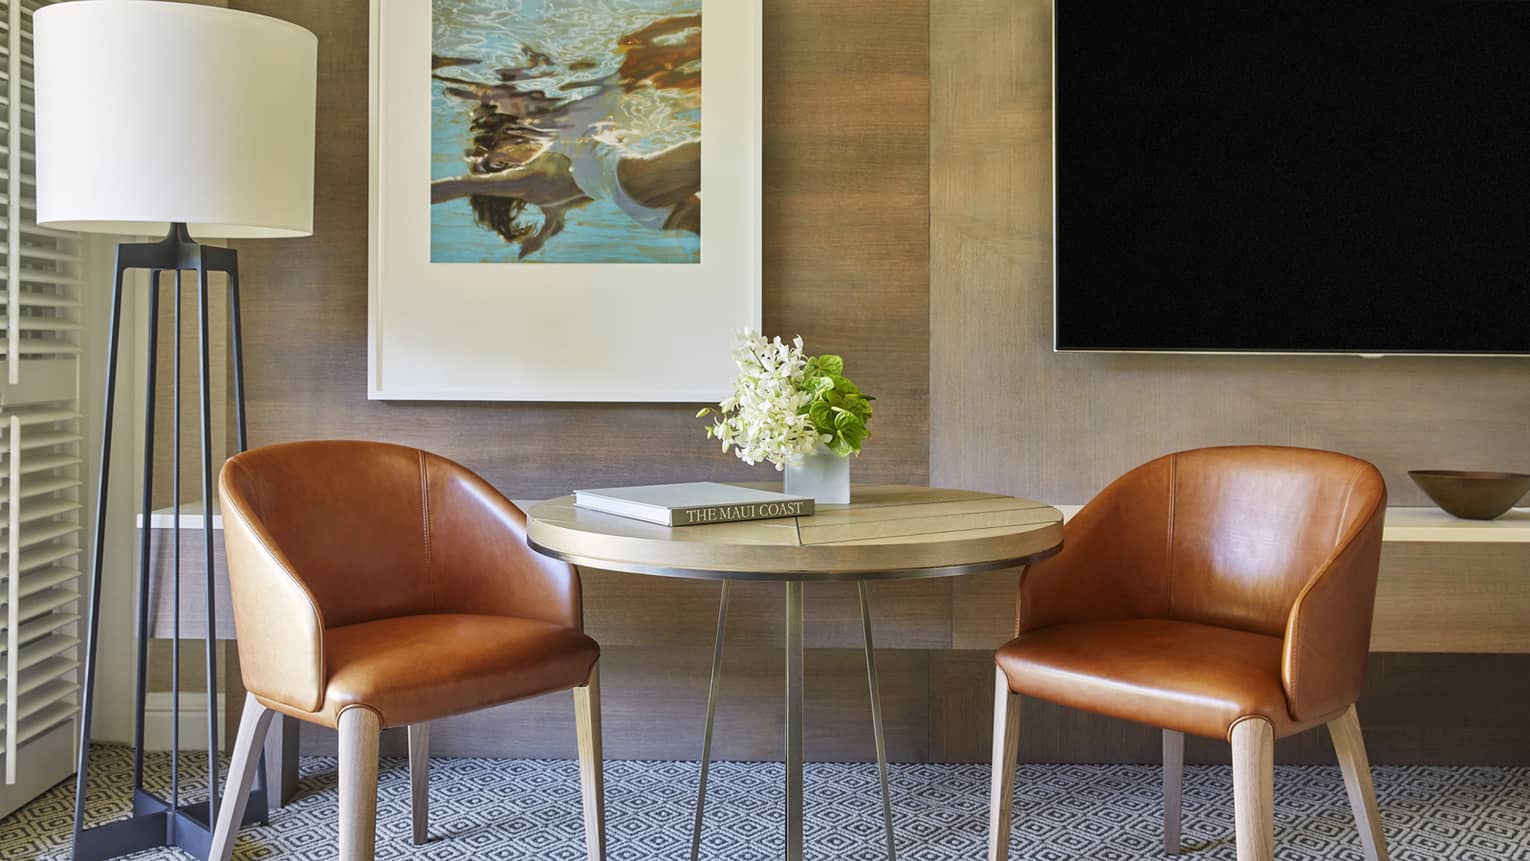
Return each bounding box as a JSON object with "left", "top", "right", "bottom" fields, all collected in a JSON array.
[{"left": 367, "top": 0, "right": 762, "bottom": 404}]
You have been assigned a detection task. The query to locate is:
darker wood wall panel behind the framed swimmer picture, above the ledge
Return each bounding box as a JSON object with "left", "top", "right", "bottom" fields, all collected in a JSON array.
[{"left": 221, "top": 0, "right": 929, "bottom": 499}]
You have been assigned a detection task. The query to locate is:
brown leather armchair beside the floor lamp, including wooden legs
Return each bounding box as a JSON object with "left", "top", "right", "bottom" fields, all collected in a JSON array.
[{"left": 211, "top": 442, "right": 606, "bottom": 861}]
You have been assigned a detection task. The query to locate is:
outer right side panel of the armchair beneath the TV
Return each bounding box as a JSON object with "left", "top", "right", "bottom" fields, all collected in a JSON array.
[{"left": 1281, "top": 489, "right": 1386, "bottom": 720}]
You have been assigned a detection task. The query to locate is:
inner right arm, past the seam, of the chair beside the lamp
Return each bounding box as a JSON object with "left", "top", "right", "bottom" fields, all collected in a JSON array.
[{"left": 427, "top": 456, "right": 584, "bottom": 630}]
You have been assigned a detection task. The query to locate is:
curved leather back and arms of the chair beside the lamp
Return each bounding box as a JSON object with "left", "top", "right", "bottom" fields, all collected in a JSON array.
[{"left": 219, "top": 440, "right": 583, "bottom": 710}]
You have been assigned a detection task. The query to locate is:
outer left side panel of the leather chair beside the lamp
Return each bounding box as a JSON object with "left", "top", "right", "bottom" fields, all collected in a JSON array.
[{"left": 220, "top": 465, "right": 329, "bottom": 711}]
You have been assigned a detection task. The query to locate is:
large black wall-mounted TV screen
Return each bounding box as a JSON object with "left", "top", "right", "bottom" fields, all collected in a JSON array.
[{"left": 1053, "top": 0, "right": 1530, "bottom": 353}]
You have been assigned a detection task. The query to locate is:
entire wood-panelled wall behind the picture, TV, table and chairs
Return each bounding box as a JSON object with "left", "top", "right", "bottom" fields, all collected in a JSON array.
[{"left": 218, "top": 0, "right": 1530, "bottom": 763}]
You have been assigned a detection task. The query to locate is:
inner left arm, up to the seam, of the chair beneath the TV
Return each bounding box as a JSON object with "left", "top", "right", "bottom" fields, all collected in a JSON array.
[{"left": 1016, "top": 457, "right": 1174, "bottom": 633}]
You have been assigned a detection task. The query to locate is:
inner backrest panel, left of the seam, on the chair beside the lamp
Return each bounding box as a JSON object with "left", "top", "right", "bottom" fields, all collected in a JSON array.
[{"left": 225, "top": 440, "right": 433, "bottom": 627}]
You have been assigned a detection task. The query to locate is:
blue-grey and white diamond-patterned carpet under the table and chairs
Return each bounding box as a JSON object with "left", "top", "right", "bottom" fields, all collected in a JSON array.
[{"left": 0, "top": 748, "right": 1530, "bottom": 861}]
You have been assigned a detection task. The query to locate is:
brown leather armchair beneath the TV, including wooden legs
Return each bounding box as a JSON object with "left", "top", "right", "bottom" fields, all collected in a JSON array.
[{"left": 988, "top": 447, "right": 1386, "bottom": 861}]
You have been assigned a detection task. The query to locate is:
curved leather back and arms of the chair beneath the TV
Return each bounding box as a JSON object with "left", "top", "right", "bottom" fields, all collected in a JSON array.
[{"left": 1017, "top": 445, "right": 1386, "bottom": 716}]
